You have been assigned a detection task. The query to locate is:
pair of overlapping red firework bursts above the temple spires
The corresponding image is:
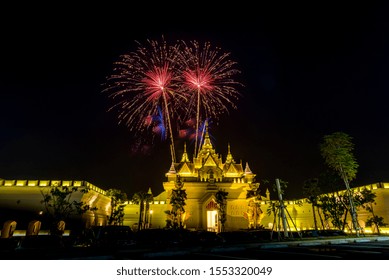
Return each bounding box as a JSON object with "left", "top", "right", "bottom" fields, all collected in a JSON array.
[{"left": 103, "top": 37, "right": 241, "bottom": 162}]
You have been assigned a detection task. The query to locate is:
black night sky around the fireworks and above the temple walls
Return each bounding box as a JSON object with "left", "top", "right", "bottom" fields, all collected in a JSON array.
[{"left": 0, "top": 2, "right": 389, "bottom": 198}]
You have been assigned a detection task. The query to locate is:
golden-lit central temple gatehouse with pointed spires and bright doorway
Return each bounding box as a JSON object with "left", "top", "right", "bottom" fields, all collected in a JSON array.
[{"left": 125, "top": 123, "right": 269, "bottom": 232}]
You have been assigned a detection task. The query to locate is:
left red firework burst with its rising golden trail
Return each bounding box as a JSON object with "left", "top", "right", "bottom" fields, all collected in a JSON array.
[{"left": 103, "top": 38, "right": 185, "bottom": 162}]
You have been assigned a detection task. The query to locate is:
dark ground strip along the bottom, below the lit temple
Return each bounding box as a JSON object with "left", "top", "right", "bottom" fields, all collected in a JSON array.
[{"left": 0, "top": 230, "right": 389, "bottom": 260}]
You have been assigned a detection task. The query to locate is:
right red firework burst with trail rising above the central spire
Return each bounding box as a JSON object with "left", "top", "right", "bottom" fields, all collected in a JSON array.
[{"left": 181, "top": 41, "right": 241, "bottom": 156}]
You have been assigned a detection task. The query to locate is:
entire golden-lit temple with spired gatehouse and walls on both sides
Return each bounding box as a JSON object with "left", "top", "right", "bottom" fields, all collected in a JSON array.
[{"left": 0, "top": 127, "right": 389, "bottom": 236}]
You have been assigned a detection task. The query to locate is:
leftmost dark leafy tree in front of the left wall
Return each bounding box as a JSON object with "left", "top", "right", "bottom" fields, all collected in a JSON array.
[{"left": 41, "top": 185, "right": 97, "bottom": 235}]
